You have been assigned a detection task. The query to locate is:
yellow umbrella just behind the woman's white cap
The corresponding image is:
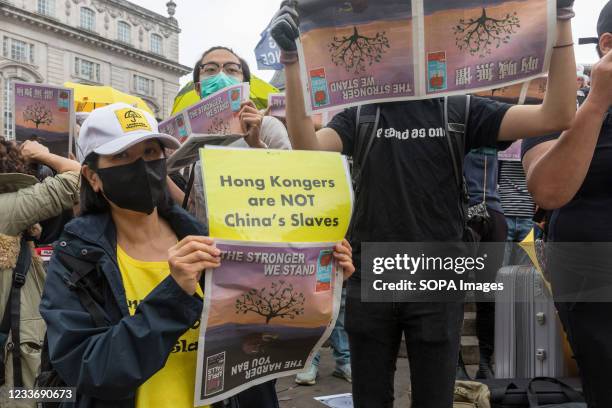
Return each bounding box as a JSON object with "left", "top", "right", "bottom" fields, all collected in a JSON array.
[{"left": 64, "top": 82, "right": 153, "bottom": 115}]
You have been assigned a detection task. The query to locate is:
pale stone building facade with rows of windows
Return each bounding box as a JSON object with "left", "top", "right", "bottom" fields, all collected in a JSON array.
[{"left": 0, "top": 0, "right": 191, "bottom": 137}]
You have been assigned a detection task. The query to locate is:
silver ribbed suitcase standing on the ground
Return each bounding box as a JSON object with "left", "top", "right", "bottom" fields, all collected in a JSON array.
[{"left": 495, "top": 265, "right": 569, "bottom": 378}]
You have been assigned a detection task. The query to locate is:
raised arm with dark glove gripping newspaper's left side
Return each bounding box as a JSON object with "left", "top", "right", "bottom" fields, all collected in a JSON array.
[{"left": 271, "top": 1, "right": 342, "bottom": 152}]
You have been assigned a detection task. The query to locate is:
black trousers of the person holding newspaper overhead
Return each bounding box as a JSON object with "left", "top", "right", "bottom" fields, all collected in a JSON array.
[{"left": 345, "top": 278, "right": 463, "bottom": 408}]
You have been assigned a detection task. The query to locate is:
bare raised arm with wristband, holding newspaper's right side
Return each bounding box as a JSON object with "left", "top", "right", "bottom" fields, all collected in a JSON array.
[{"left": 498, "top": 0, "right": 576, "bottom": 141}]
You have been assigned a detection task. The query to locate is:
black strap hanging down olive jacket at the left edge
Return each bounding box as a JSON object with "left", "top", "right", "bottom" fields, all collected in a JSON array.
[{"left": 0, "top": 234, "right": 32, "bottom": 388}]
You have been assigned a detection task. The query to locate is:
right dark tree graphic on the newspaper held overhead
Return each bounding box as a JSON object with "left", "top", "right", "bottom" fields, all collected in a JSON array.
[{"left": 453, "top": 8, "right": 521, "bottom": 58}]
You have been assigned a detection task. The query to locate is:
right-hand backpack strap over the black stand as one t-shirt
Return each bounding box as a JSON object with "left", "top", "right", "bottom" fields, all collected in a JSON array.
[{"left": 444, "top": 95, "right": 471, "bottom": 225}]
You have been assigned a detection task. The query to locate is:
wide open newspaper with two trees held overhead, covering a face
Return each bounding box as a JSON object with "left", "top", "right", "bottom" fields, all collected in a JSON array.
[{"left": 298, "top": 0, "right": 556, "bottom": 112}]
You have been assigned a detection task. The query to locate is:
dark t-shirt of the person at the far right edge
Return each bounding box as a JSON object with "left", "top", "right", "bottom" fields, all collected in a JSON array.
[{"left": 522, "top": 109, "right": 612, "bottom": 242}]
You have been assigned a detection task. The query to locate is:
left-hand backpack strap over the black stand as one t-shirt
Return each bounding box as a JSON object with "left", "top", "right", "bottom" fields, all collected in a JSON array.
[{"left": 347, "top": 105, "right": 380, "bottom": 239}]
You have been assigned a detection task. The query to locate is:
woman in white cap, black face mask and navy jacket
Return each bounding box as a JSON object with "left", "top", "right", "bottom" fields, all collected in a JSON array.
[{"left": 41, "top": 104, "right": 219, "bottom": 408}]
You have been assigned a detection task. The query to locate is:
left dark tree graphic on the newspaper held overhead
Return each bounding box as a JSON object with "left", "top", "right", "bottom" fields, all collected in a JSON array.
[{"left": 329, "top": 26, "right": 391, "bottom": 74}]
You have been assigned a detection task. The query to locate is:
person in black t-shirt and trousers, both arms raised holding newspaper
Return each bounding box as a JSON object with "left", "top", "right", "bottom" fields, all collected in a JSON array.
[{"left": 271, "top": 1, "right": 576, "bottom": 408}]
